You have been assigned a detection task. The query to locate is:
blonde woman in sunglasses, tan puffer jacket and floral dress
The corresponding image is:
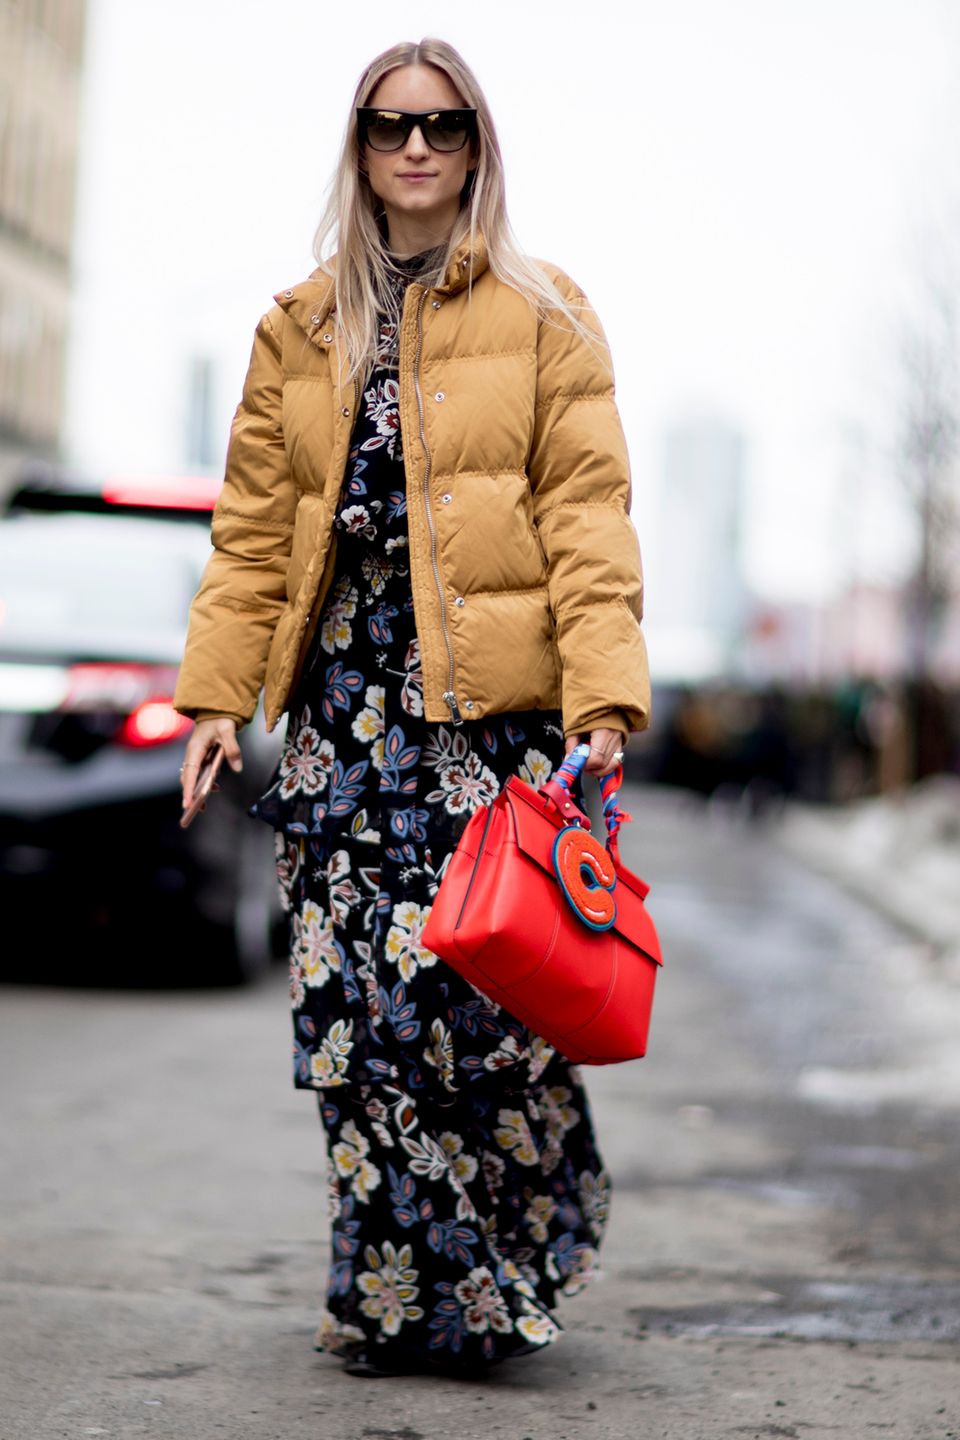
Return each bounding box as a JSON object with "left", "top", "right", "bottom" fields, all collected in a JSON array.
[{"left": 177, "top": 40, "right": 648, "bottom": 1375}]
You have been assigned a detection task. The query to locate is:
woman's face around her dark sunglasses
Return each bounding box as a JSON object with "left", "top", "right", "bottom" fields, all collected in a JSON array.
[{"left": 363, "top": 65, "right": 476, "bottom": 249}]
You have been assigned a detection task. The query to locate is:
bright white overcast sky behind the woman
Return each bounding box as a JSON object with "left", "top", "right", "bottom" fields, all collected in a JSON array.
[{"left": 68, "top": 0, "right": 960, "bottom": 598}]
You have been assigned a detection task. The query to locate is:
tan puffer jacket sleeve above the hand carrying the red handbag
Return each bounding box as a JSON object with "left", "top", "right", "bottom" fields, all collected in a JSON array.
[{"left": 528, "top": 271, "right": 651, "bottom": 734}]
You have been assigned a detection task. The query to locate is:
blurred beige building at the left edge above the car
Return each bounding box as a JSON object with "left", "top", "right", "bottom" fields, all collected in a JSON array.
[{"left": 0, "top": 0, "right": 86, "bottom": 487}]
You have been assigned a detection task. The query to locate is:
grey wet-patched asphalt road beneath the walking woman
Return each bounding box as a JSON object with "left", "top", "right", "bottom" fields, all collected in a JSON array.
[{"left": 0, "top": 792, "right": 960, "bottom": 1440}]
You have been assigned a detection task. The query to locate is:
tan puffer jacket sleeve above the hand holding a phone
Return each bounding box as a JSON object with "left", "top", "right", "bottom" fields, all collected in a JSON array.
[{"left": 174, "top": 311, "right": 296, "bottom": 723}]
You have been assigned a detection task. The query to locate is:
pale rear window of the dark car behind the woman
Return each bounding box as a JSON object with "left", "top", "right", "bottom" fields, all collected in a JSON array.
[{"left": 0, "top": 514, "right": 210, "bottom": 661}]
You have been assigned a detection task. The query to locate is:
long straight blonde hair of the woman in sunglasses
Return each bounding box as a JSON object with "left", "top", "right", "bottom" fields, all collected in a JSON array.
[{"left": 314, "top": 39, "right": 606, "bottom": 379}]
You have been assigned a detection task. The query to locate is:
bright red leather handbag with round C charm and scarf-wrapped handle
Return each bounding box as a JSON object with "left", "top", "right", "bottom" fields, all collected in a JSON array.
[{"left": 423, "top": 744, "right": 662, "bottom": 1066}]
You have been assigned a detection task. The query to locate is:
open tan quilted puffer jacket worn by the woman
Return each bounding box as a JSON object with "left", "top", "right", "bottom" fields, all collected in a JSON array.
[{"left": 176, "top": 246, "right": 649, "bottom": 734}]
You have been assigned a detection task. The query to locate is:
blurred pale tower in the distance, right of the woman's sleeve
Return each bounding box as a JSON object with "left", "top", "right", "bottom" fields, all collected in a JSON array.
[{"left": 648, "top": 419, "right": 747, "bottom": 681}]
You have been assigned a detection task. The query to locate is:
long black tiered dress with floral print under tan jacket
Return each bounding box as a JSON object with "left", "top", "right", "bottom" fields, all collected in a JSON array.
[{"left": 255, "top": 250, "right": 609, "bottom": 1368}]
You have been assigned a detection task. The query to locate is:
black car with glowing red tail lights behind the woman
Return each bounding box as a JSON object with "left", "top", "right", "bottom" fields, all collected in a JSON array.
[{"left": 0, "top": 471, "right": 284, "bottom": 985}]
